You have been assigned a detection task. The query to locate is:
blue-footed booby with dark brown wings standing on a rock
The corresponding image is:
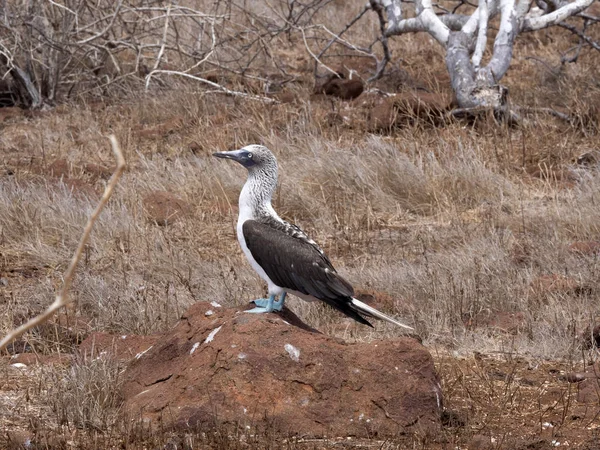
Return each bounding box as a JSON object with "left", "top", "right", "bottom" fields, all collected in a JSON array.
[{"left": 213, "top": 145, "right": 413, "bottom": 330}]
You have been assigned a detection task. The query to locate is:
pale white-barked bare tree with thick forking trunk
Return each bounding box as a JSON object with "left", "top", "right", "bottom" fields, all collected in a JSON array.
[{"left": 371, "top": 0, "right": 600, "bottom": 109}]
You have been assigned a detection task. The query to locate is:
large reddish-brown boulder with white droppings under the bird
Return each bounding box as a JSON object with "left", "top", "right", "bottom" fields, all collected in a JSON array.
[{"left": 122, "top": 303, "right": 442, "bottom": 437}]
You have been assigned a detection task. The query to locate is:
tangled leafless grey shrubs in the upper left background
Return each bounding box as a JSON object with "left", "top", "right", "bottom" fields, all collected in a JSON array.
[{"left": 0, "top": 0, "right": 340, "bottom": 108}]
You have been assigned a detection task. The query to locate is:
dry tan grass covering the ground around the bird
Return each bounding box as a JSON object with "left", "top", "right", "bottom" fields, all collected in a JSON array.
[{"left": 0, "top": 2, "right": 600, "bottom": 449}]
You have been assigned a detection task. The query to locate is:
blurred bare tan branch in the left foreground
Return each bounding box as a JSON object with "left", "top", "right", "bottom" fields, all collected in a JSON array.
[{"left": 0, "top": 135, "right": 125, "bottom": 351}]
